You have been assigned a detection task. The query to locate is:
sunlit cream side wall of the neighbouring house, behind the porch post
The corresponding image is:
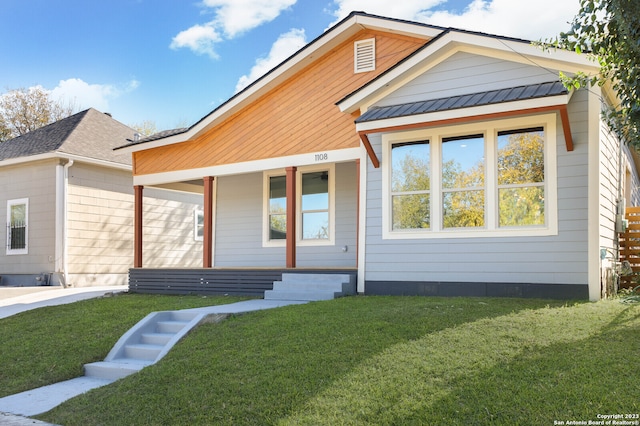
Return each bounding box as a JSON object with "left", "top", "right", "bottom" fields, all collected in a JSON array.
[{"left": 67, "top": 163, "right": 202, "bottom": 286}]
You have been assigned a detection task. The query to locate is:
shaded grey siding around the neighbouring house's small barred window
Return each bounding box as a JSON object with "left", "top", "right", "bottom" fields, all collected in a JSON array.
[{"left": 0, "top": 160, "right": 57, "bottom": 285}]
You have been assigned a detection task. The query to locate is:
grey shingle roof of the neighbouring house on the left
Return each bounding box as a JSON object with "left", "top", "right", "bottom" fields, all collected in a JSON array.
[{"left": 0, "top": 108, "right": 134, "bottom": 165}]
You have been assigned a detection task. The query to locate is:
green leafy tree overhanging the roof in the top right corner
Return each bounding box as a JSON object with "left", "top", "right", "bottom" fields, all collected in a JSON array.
[{"left": 543, "top": 0, "right": 640, "bottom": 147}]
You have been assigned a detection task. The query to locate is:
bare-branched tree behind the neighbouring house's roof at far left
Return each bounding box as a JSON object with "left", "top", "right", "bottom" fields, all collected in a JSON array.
[{"left": 0, "top": 86, "right": 75, "bottom": 142}]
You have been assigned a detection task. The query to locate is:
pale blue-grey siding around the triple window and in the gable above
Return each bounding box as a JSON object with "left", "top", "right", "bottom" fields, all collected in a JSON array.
[{"left": 365, "top": 53, "right": 589, "bottom": 292}]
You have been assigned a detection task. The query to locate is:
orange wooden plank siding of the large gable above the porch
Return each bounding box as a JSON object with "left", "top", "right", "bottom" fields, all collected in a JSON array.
[{"left": 134, "top": 31, "right": 425, "bottom": 175}]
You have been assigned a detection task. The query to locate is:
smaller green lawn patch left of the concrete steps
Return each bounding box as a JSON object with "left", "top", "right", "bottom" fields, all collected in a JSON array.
[{"left": 0, "top": 294, "right": 248, "bottom": 397}]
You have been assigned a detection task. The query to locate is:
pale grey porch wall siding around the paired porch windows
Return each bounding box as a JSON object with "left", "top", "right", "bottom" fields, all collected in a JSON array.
[{"left": 214, "top": 163, "right": 357, "bottom": 267}]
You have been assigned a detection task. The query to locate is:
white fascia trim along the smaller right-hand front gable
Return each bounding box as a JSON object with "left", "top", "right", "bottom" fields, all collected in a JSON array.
[{"left": 338, "top": 30, "right": 598, "bottom": 113}]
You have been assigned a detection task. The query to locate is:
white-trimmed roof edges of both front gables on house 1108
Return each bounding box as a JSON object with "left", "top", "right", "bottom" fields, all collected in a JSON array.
[{"left": 117, "top": 12, "right": 594, "bottom": 159}]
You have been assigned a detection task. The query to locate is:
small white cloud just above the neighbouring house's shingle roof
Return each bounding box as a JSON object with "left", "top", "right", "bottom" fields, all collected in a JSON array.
[{"left": 50, "top": 78, "right": 140, "bottom": 112}]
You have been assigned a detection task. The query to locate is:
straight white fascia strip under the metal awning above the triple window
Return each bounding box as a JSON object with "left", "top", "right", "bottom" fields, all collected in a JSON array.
[{"left": 356, "top": 95, "right": 569, "bottom": 132}]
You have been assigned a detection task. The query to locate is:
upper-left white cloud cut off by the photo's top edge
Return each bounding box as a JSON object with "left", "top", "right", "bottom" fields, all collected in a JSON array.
[{"left": 170, "top": 0, "right": 297, "bottom": 59}]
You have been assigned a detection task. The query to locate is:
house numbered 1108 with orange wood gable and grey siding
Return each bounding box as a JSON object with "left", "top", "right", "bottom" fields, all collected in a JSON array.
[{"left": 118, "top": 12, "right": 638, "bottom": 300}]
